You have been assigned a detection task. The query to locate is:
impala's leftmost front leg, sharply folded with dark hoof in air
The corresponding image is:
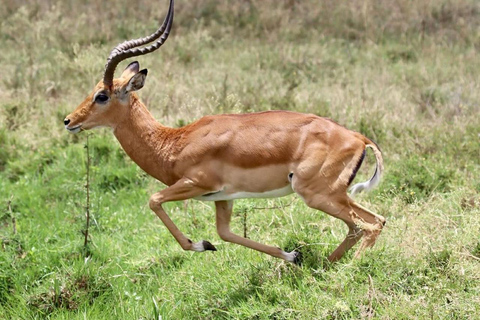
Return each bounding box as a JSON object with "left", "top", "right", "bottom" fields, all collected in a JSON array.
[{"left": 149, "top": 178, "right": 217, "bottom": 252}]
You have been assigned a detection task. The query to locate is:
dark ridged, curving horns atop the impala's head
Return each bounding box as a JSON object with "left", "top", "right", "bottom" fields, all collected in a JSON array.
[{"left": 103, "top": 0, "right": 174, "bottom": 86}]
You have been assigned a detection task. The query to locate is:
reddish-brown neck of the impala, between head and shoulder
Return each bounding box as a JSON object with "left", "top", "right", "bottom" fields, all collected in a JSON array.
[{"left": 114, "top": 94, "right": 175, "bottom": 185}]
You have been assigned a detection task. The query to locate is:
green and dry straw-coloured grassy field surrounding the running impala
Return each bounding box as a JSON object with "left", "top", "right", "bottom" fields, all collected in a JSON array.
[{"left": 0, "top": 0, "right": 480, "bottom": 319}]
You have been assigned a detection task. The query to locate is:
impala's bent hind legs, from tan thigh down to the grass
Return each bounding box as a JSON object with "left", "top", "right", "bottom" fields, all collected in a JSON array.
[{"left": 289, "top": 141, "right": 385, "bottom": 262}]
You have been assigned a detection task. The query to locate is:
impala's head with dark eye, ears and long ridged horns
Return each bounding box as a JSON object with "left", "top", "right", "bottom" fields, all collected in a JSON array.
[{"left": 63, "top": 0, "right": 174, "bottom": 133}]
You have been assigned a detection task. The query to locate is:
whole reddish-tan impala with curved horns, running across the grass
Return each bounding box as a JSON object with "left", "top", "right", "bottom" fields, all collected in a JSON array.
[{"left": 64, "top": 0, "right": 385, "bottom": 262}]
